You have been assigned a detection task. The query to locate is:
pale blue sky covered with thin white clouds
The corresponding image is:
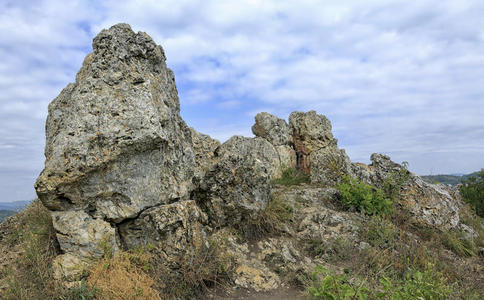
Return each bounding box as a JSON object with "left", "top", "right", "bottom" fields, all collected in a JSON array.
[{"left": 0, "top": 0, "right": 484, "bottom": 202}]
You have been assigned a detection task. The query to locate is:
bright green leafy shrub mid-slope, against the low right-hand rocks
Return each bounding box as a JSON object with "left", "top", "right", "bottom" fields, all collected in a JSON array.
[{"left": 336, "top": 176, "right": 393, "bottom": 215}]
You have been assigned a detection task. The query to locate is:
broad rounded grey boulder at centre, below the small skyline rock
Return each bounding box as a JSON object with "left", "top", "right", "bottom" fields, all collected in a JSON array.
[{"left": 194, "top": 136, "right": 279, "bottom": 225}]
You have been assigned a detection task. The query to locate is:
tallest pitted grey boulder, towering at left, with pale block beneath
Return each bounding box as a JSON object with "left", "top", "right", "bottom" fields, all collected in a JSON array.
[{"left": 35, "top": 24, "right": 194, "bottom": 256}]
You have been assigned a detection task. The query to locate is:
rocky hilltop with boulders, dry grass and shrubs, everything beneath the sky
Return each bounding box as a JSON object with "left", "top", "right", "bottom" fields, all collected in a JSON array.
[{"left": 0, "top": 24, "right": 484, "bottom": 299}]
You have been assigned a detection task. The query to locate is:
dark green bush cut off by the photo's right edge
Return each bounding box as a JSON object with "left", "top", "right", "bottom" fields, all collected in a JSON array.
[{"left": 459, "top": 169, "right": 484, "bottom": 217}]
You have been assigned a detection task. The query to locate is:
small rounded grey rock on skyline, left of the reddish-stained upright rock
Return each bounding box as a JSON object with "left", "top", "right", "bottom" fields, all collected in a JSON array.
[{"left": 252, "top": 112, "right": 292, "bottom": 146}]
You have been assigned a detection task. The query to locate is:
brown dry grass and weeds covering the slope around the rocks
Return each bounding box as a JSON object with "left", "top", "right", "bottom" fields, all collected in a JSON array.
[{"left": 0, "top": 191, "right": 484, "bottom": 300}]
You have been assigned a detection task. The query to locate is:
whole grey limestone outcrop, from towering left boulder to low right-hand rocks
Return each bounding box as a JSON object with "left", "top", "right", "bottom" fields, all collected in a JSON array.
[{"left": 1, "top": 24, "right": 482, "bottom": 298}]
